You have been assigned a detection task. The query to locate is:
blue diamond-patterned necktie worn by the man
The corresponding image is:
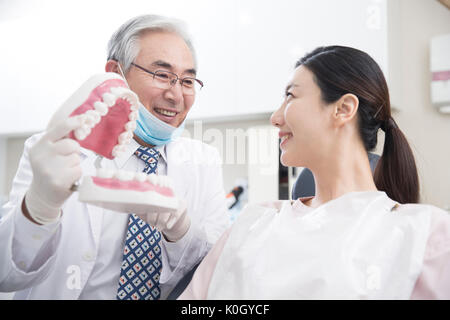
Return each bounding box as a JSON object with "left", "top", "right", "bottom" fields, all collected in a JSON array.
[{"left": 117, "top": 146, "right": 161, "bottom": 300}]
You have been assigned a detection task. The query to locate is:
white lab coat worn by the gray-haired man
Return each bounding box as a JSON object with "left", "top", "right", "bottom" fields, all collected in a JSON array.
[{"left": 0, "top": 134, "right": 229, "bottom": 299}]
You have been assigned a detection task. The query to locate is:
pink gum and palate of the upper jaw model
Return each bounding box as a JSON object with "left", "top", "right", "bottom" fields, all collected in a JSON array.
[{"left": 69, "top": 79, "right": 131, "bottom": 159}]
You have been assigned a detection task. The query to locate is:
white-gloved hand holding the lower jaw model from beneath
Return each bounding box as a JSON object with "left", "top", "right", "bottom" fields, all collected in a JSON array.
[{"left": 145, "top": 200, "right": 191, "bottom": 242}]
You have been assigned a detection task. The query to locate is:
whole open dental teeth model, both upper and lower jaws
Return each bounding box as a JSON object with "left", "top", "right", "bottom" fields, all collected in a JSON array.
[{"left": 48, "top": 73, "right": 179, "bottom": 214}]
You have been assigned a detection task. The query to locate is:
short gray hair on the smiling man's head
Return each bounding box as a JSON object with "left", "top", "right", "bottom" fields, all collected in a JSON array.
[{"left": 108, "top": 14, "right": 197, "bottom": 73}]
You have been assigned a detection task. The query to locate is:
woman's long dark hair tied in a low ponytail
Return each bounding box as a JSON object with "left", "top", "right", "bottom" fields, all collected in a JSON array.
[{"left": 295, "top": 46, "right": 419, "bottom": 203}]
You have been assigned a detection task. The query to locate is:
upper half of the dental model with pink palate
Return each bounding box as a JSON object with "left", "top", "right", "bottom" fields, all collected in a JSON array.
[{"left": 49, "top": 73, "right": 139, "bottom": 159}]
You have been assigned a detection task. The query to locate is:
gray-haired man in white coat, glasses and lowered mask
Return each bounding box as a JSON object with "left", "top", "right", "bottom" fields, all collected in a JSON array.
[{"left": 0, "top": 15, "right": 228, "bottom": 300}]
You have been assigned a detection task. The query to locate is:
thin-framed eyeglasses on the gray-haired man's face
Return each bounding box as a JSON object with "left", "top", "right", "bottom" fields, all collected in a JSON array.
[{"left": 131, "top": 62, "right": 203, "bottom": 96}]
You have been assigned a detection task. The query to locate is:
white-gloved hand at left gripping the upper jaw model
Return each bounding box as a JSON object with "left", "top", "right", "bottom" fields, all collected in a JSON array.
[{"left": 25, "top": 117, "right": 81, "bottom": 224}]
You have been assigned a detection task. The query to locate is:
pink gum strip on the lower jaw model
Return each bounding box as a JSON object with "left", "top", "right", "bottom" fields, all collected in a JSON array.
[{"left": 92, "top": 177, "right": 174, "bottom": 197}]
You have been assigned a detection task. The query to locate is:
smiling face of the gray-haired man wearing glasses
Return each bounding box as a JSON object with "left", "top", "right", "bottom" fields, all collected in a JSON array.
[{"left": 126, "top": 31, "right": 195, "bottom": 127}]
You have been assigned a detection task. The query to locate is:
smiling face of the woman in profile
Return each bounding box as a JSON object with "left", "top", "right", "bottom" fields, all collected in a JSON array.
[{"left": 271, "top": 66, "right": 333, "bottom": 167}]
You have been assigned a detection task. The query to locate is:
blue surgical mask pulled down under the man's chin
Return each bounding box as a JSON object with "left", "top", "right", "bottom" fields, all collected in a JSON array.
[{"left": 117, "top": 63, "right": 186, "bottom": 146}]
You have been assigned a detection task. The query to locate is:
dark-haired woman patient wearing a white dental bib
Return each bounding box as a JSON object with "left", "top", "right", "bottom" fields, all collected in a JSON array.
[{"left": 180, "top": 46, "right": 450, "bottom": 299}]
